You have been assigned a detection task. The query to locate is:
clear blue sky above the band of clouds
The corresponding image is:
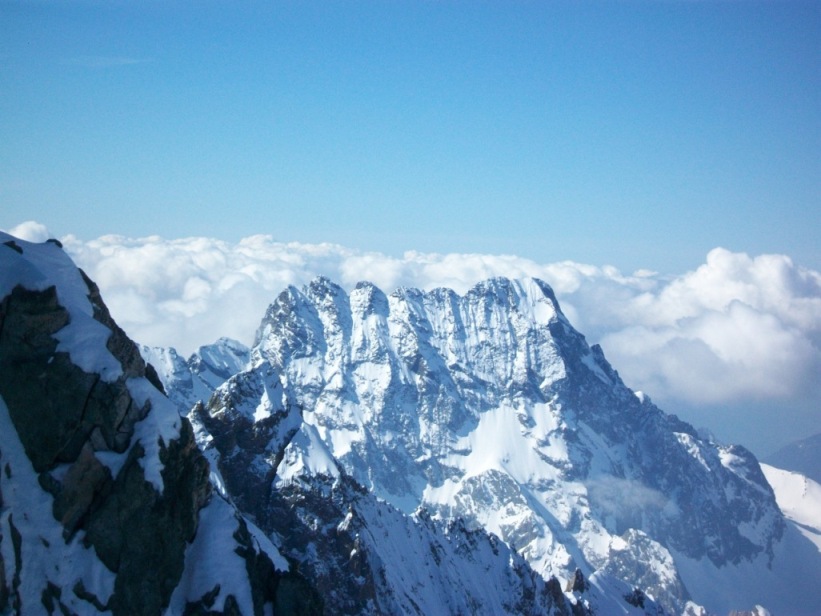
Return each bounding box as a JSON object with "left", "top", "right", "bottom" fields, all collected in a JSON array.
[{"left": 0, "top": 1, "right": 821, "bottom": 272}]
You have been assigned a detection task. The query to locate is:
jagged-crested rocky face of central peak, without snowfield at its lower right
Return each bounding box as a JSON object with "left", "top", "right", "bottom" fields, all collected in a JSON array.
[{"left": 243, "top": 278, "right": 780, "bottom": 592}]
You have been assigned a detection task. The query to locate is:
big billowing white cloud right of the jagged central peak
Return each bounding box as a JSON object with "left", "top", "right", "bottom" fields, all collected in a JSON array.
[{"left": 588, "top": 248, "right": 821, "bottom": 403}]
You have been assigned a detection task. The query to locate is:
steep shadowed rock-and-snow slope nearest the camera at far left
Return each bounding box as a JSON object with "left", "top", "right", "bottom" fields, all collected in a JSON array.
[{"left": 0, "top": 234, "right": 320, "bottom": 615}]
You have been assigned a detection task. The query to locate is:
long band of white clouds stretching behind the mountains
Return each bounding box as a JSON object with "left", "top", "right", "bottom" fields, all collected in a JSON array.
[{"left": 9, "top": 222, "right": 821, "bottom": 447}]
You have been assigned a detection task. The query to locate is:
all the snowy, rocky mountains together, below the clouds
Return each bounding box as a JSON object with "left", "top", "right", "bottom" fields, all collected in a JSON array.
[{"left": 0, "top": 236, "right": 821, "bottom": 614}]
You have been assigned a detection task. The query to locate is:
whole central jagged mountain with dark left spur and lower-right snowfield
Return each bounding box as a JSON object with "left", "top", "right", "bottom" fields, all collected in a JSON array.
[{"left": 181, "top": 278, "right": 821, "bottom": 614}]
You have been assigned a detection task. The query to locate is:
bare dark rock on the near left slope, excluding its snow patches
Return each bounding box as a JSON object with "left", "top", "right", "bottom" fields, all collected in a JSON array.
[{"left": 0, "top": 287, "right": 197, "bottom": 614}]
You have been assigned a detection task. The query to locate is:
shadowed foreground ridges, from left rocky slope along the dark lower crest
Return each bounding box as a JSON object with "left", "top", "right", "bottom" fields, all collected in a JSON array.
[{"left": 0, "top": 236, "right": 656, "bottom": 615}]
